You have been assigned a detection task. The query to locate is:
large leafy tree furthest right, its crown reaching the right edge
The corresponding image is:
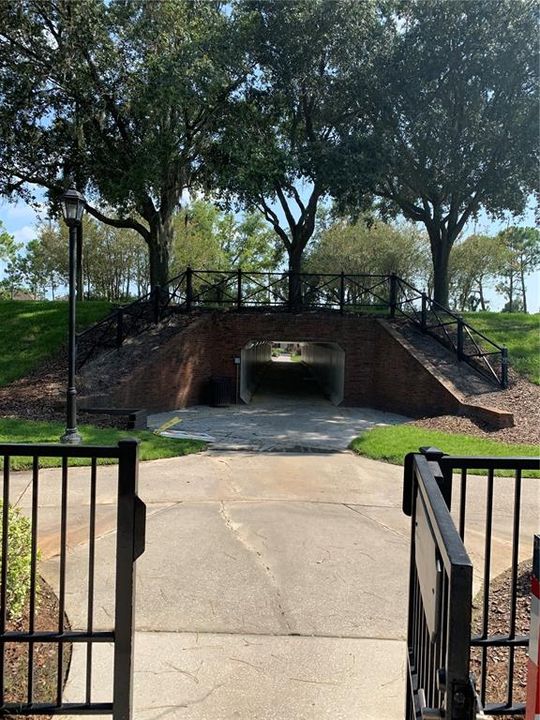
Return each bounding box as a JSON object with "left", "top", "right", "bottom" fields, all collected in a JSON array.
[{"left": 334, "top": 0, "right": 538, "bottom": 305}]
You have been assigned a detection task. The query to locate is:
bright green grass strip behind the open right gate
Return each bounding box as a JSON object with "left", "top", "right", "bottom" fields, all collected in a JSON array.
[{"left": 350, "top": 424, "right": 540, "bottom": 465}]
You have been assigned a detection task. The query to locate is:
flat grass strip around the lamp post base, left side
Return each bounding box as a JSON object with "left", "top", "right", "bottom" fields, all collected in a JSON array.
[{"left": 0, "top": 418, "right": 206, "bottom": 470}]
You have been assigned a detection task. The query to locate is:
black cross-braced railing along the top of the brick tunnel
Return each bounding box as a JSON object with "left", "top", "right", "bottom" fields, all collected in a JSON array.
[{"left": 77, "top": 268, "right": 508, "bottom": 388}]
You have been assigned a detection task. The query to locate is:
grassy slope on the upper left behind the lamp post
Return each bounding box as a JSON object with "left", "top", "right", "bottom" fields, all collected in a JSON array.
[{"left": 0, "top": 300, "right": 113, "bottom": 386}]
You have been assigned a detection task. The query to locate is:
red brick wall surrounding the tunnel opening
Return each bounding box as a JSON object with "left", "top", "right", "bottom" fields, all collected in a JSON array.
[{"left": 112, "top": 312, "right": 472, "bottom": 417}]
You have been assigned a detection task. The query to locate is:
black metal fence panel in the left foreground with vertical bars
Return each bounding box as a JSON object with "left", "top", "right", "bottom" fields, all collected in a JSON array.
[{"left": 0, "top": 440, "right": 145, "bottom": 720}]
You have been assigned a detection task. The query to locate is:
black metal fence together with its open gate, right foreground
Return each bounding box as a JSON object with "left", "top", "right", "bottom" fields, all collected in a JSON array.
[{"left": 403, "top": 448, "right": 540, "bottom": 720}]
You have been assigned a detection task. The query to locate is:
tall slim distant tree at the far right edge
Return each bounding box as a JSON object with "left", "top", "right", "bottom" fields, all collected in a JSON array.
[{"left": 497, "top": 227, "right": 540, "bottom": 312}]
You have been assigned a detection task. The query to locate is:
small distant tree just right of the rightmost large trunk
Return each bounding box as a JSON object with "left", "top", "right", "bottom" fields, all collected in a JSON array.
[{"left": 449, "top": 235, "right": 503, "bottom": 311}]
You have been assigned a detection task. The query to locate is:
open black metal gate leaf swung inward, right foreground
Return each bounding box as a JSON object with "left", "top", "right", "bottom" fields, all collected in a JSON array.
[{"left": 403, "top": 453, "right": 474, "bottom": 720}]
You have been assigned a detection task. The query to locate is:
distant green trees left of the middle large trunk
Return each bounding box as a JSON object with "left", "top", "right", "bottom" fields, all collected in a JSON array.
[{"left": 0, "top": 200, "right": 283, "bottom": 301}]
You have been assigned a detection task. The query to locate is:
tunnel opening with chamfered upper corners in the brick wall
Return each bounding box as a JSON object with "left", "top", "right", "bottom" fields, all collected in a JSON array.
[{"left": 240, "top": 340, "right": 345, "bottom": 405}]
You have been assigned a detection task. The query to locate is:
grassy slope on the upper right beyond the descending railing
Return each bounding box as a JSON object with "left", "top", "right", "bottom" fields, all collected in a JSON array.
[{"left": 463, "top": 312, "right": 540, "bottom": 385}]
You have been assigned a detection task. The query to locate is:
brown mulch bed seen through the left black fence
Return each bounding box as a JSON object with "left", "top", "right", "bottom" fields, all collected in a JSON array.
[{"left": 4, "top": 578, "right": 71, "bottom": 720}]
